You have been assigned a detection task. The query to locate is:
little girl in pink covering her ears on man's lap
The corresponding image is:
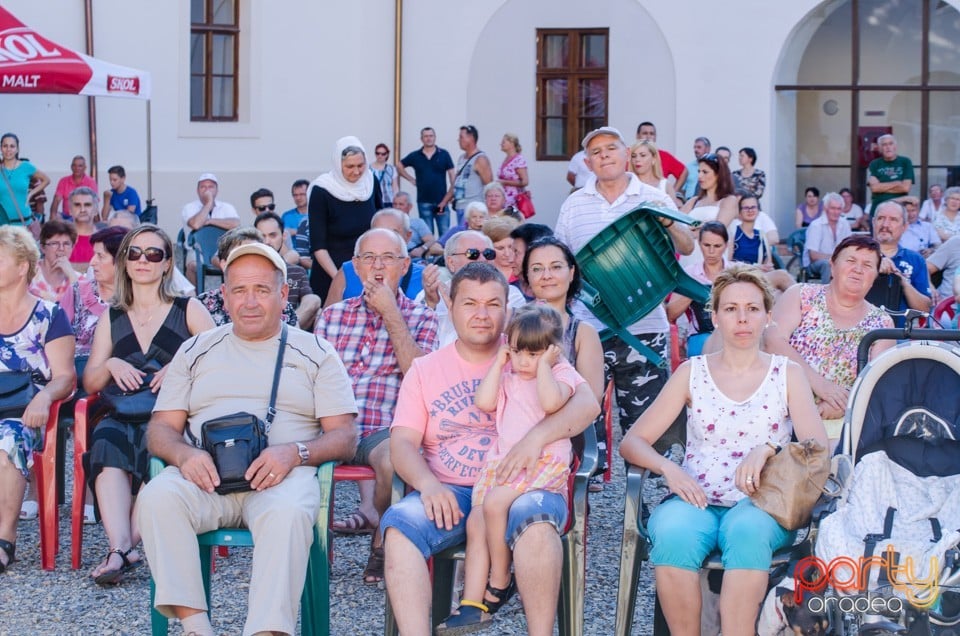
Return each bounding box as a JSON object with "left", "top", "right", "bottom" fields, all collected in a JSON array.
[{"left": 437, "top": 305, "right": 585, "bottom": 634}]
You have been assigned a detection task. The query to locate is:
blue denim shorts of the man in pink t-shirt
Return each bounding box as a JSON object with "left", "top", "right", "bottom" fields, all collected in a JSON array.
[{"left": 380, "top": 484, "right": 567, "bottom": 558}]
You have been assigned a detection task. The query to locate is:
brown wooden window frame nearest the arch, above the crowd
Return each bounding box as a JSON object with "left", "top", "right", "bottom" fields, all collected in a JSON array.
[{"left": 536, "top": 28, "right": 610, "bottom": 161}]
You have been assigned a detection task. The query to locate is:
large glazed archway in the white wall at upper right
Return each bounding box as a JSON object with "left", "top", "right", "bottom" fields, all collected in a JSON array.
[{"left": 775, "top": 0, "right": 960, "bottom": 202}]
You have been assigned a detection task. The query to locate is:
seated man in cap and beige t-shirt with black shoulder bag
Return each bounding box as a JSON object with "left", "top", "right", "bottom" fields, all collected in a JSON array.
[{"left": 137, "top": 243, "right": 357, "bottom": 636}]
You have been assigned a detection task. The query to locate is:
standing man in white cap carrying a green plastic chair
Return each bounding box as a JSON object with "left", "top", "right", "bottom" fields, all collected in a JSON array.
[{"left": 555, "top": 126, "right": 693, "bottom": 460}]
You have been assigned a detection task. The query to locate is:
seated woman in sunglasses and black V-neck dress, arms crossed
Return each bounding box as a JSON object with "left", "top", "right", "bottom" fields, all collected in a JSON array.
[{"left": 83, "top": 225, "right": 214, "bottom": 585}]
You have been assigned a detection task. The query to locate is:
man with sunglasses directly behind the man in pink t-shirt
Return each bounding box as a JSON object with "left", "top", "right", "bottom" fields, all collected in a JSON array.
[{"left": 416, "top": 230, "right": 527, "bottom": 347}]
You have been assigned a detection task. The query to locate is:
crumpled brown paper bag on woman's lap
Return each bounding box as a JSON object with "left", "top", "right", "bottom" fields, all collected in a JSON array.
[{"left": 750, "top": 439, "right": 830, "bottom": 530}]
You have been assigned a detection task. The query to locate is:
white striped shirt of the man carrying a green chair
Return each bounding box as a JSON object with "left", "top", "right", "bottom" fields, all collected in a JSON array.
[{"left": 554, "top": 172, "right": 677, "bottom": 333}]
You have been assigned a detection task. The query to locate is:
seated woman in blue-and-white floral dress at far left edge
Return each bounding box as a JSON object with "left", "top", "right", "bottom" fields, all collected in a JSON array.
[{"left": 0, "top": 225, "right": 77, "bottom": 573}]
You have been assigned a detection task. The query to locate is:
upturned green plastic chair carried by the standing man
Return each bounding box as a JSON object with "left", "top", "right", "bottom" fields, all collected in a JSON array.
[{"left": 577, "top": 203, "right": 710, "bottom": 367}]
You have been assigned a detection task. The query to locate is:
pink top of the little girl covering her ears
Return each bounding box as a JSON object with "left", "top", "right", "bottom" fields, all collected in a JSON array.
[{"left": 490, "top": 360, "right": 586, "bottom": 463}]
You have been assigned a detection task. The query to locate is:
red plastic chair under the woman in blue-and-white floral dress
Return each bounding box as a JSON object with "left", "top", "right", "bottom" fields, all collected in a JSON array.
[{"left": 33, "top": 391, "right": 73, "bottom": 570}]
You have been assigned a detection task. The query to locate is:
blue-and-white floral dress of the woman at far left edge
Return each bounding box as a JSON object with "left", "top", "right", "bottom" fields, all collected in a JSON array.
[{"left": 0, "top": 300, "right": 73, "bottom": 478}]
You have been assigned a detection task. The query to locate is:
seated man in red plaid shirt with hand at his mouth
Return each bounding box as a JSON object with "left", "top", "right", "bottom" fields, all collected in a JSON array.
[{"left": 315, "top": 229, "right": 438, "bottom": 584}]
